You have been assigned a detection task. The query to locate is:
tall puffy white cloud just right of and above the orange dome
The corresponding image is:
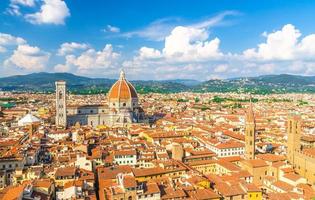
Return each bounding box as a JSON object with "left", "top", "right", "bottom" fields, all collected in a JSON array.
[{"left": 134, "top": 26, "right": 223, "bottom": 63}]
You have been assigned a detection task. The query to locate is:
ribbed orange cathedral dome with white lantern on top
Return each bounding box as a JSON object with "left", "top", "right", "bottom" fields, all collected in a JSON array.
[{"left": 108, "top": 71, "right": 138, "bottom": 101}]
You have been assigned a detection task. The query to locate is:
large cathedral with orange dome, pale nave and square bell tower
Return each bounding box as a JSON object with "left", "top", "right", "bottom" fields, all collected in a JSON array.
[{"left": 56, "top": 71, "right": 144, "bottom": 127}]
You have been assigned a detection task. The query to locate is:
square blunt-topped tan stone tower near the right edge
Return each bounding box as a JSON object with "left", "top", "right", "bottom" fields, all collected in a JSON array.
[{"left": 287, "top": 114, "right": 301, "bottom": 166}]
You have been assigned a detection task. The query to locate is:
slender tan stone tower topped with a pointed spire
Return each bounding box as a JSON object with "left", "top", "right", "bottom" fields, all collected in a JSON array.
[{"left": 245, "top": 99, "right": 256, "bottom": 159}]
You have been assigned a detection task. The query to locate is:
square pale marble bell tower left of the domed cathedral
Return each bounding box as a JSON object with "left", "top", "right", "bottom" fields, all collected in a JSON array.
[{"left": 55, "top": 81, "right": 67, "bottom": 128}]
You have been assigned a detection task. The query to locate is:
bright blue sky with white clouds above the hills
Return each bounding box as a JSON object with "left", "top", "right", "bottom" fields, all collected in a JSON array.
[{"left": 0, "top": 0, "right": 315, "bottom": 80}]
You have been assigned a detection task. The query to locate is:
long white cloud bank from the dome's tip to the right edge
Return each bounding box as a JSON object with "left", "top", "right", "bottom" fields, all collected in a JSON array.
[{"left": 123, "top": 24, "right": 315, "bottom": 79}]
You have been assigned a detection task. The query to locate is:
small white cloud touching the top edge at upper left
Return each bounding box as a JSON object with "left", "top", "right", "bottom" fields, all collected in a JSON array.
[{"left": 25, "top": 0, "right": 70, "bottom": 25}]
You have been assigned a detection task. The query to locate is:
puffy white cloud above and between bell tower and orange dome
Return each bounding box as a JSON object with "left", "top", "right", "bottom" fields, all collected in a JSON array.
[{"left": 55, "top": 44, "right": 120, "bottom": 74}]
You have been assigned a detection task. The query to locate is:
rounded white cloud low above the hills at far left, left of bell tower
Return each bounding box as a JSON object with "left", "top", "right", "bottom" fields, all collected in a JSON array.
[{"left": 4, "top": 44, "right": 50, "bottom": 71}]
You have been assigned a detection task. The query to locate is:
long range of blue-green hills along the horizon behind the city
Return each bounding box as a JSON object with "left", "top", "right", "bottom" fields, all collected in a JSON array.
[{"left": 0, "top": 72, "right": 315, "bottom": 94}]
